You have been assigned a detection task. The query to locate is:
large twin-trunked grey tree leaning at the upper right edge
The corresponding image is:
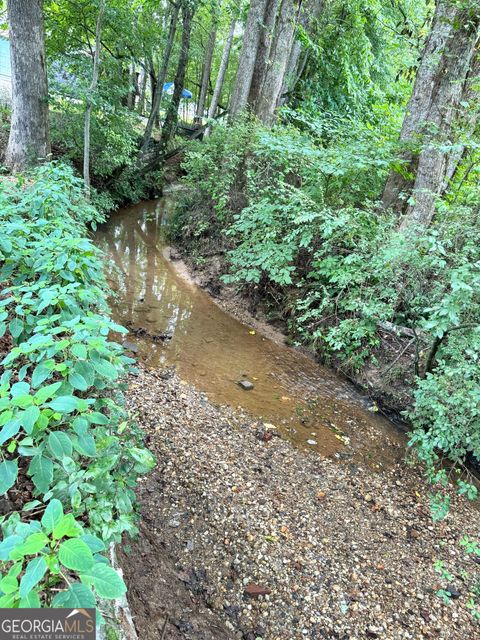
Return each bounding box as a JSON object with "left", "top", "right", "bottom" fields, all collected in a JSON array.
[{"left": 383, "top": 0, "right": 480, "bottom": 230}]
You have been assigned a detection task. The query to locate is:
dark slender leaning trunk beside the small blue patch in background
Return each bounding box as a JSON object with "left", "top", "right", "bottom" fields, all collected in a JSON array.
[{"left": 160, "top": 0, "right": 194, "bottom": 158}]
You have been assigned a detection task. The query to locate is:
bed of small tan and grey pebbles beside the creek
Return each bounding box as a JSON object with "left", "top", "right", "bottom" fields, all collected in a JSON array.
[{"left": 122, "top": 370, "right": 479, "bottom": 640}]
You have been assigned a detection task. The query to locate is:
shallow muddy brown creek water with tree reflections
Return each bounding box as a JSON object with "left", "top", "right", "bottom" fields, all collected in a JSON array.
[{"left": 96, "top": 196, "right": 405, "bottom": 467}]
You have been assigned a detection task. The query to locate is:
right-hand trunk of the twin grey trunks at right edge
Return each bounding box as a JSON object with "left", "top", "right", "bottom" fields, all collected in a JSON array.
[{"left": 400, "top": 5, "right": 480, "bottom": 231}]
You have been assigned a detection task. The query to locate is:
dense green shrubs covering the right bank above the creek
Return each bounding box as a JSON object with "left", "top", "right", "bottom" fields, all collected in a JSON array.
[{"left": 173, "top": 107, "right": 480, "bottom": 497}]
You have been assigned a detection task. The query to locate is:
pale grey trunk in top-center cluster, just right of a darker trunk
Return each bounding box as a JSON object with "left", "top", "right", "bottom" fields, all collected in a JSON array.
[{"left": 255, "top": 0, "right": 298, "bottom": 125}]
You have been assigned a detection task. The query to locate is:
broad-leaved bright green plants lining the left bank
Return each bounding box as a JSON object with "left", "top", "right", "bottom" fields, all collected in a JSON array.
[{"left": 0, "top": 164, "right": 154, "bottom": 607}]
